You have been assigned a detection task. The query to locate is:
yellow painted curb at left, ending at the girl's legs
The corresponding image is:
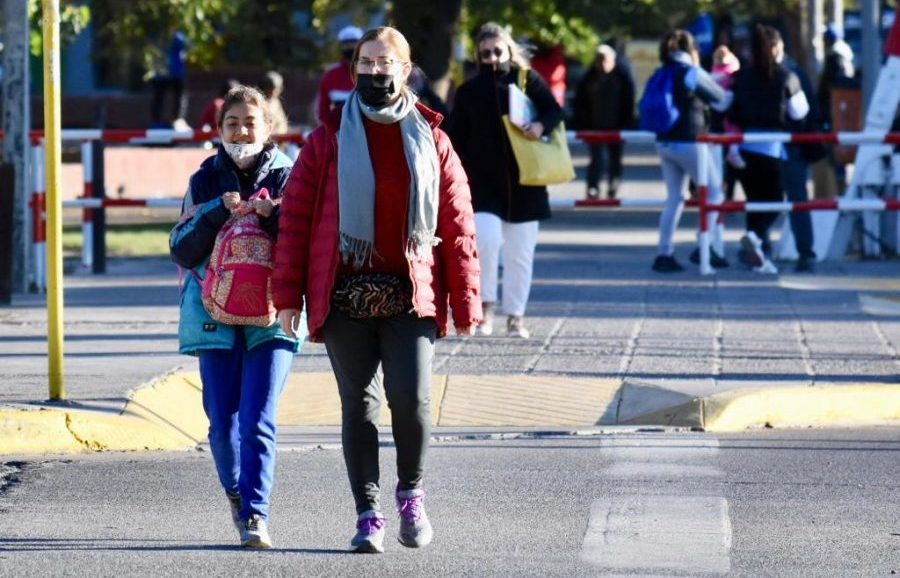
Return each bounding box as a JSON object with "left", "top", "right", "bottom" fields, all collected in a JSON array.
[{"left": 0, "top": 374, "right": 208, "bottom": 455}]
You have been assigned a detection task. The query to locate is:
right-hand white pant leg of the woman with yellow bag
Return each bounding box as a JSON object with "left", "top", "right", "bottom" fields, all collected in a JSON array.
[{"left": 503, "top": 221, "right": 538, "bottom": 317}]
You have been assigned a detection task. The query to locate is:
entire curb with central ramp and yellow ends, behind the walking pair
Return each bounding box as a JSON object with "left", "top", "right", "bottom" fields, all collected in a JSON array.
[{"left": 0, "top": 372, "right": 900, "bottom": 455}]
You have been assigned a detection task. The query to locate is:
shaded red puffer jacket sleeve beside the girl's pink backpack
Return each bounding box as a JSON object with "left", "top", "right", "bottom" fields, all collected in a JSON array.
[{"left": 272, "top": 126, "right": 326, "bottom": 311}]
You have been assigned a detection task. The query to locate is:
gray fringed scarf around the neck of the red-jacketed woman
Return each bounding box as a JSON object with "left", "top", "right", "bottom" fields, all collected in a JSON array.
[{"left": 337, "top": 91, "right": 441, "bottom": 269}]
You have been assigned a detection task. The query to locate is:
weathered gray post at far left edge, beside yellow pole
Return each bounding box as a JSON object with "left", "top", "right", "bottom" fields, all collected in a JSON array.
[{"left": 0, "top": 0, "right": 31, "bottom": 291}]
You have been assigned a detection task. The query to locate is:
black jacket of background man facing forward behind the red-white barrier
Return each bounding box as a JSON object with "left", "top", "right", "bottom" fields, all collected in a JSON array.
[{"left": 574, "top": 65, "right": 634, "bottom": 130}]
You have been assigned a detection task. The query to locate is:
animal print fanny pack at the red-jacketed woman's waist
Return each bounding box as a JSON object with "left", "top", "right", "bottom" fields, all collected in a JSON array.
[{"left": 331, "top": 273, "right": 412, "bottom": 319}]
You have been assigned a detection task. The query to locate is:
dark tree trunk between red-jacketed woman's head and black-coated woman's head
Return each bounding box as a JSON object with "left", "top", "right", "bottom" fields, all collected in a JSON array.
[{"left": 391, "top": 0, "right": 462, "bottom": 98}]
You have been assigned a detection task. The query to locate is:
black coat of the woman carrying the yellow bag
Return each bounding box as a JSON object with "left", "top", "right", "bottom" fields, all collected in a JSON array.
[{"left": 444, "top": 66, "right": 563, "bottom": 223}]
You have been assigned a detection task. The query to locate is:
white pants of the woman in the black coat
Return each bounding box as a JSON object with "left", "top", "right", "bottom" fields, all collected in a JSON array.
[{"left": 475, "top": 213, "right": 538, "bottom": 316}]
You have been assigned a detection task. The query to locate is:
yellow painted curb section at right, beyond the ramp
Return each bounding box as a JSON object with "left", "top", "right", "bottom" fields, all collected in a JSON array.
[{"left": 702, "top": 384, "right": 900, "bottom": 432}]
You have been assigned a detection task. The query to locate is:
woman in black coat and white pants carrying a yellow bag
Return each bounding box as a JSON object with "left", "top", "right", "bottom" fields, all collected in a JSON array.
[{"left": 446, "top": 22, "right": 563, "bottom": 339}]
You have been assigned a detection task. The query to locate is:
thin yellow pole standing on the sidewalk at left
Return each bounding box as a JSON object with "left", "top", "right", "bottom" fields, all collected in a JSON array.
[{"left": 43, "top": 0, "right": 66, "bottom": 400}]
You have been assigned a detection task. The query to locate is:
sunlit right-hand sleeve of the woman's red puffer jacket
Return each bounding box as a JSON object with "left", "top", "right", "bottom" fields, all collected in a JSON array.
[{"left": 434, "top": 129, "right": 482, "bottom": 327}]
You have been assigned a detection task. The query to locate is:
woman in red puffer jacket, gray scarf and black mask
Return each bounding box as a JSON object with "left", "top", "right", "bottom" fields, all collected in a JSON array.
[{"left": 272, "top": 27, "right": 482, "bottom": 552}]
